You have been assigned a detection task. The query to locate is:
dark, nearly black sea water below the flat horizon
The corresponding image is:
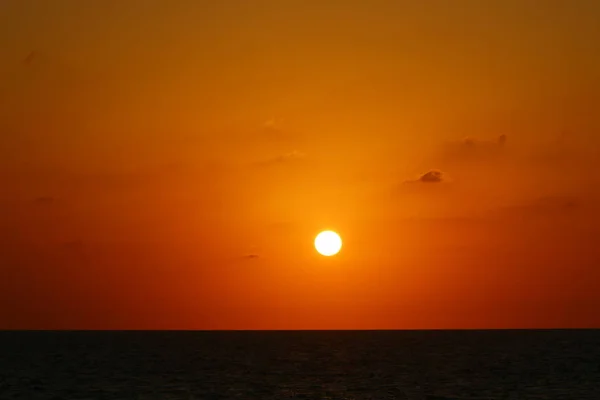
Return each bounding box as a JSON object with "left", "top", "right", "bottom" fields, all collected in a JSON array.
[{"left": 0, "top": 330, "right": 600, "bottom": 400}]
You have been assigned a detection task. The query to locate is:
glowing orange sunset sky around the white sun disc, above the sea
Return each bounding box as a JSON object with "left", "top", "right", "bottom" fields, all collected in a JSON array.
[{"left": 0, "top": 0, "right": 600, "bottom": 329}]
